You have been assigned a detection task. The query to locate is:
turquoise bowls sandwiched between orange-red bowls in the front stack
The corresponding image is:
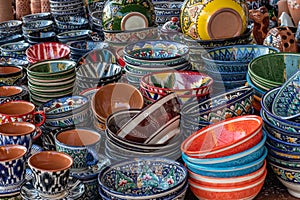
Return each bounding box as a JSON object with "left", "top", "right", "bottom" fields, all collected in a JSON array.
[{"left": 182, "top": 147, "right": 268, "bottom": 178}]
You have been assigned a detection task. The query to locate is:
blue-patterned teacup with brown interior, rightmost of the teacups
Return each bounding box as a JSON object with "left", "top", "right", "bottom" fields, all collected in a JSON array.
[{"left": 55, "top": 128, "right": 101, "bottom": 170}]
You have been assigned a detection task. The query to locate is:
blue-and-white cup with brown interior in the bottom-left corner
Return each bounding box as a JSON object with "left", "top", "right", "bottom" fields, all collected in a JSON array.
[{"left": 0, "top": 145, "right": 27, "bottom": 190}]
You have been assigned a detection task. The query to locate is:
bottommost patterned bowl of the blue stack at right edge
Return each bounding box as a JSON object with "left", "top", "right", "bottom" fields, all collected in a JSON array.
[{"left": 270, "top": 162, "right": 300, "bottom": 198}]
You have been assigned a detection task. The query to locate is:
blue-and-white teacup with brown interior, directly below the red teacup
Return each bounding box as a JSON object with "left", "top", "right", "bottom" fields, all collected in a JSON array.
[{"left": 0, "top": 122, "right": 42, "bottom": 155}]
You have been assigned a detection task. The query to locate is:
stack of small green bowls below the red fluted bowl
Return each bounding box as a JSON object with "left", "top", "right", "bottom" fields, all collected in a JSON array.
[{"left": 27, "top": 60, "right": 76, "bottom": 106}]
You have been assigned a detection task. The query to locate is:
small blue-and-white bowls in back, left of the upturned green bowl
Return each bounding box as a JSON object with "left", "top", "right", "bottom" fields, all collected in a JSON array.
[{"left": 54, "top": 15, "right": 89, "bottom": 33}]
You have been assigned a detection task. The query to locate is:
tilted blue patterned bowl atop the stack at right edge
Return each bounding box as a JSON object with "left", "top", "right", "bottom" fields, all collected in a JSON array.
[{"left": 272, "top": 71, "right": 300, "bottom": 119}]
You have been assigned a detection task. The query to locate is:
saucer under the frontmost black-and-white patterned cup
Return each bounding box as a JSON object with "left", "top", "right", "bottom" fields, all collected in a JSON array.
[{"left": 20, "top": 177, "right": 85, "bottom": 200}]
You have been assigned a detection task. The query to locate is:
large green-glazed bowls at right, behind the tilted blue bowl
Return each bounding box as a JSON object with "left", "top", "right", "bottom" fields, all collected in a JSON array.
[{"left": 247, "top": 53, "right": 300, "bottom": 97}]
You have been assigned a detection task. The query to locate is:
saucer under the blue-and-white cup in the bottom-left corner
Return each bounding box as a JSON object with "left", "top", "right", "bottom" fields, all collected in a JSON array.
[{"left": 0, "top": 168, "right": 32, "bottom": 199}]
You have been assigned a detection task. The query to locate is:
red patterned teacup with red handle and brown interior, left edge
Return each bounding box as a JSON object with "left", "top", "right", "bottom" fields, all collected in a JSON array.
[{"left": 0, "top": 100, "right": 46, "bottom": 126}]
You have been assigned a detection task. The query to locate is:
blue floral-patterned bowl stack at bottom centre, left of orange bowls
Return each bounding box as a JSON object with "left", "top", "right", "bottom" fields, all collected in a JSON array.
[{"left": 98, "top": 157, "right": 188, "bottom": 200}]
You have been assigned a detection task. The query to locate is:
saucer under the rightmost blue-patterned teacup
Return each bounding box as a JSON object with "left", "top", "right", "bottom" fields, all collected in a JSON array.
[{"left": 70, "top": 154, "right": 111, "bottom": 180}]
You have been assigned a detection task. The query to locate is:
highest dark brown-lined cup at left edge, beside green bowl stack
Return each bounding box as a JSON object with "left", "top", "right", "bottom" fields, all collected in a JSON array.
[{"left": 0, "top": 66, "right": 25, "bottom": 85}]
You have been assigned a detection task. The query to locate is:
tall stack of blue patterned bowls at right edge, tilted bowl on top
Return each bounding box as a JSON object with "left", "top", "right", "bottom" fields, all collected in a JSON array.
[{"left": 261, "top": 71, "right": 300, "bottom": 198}]
